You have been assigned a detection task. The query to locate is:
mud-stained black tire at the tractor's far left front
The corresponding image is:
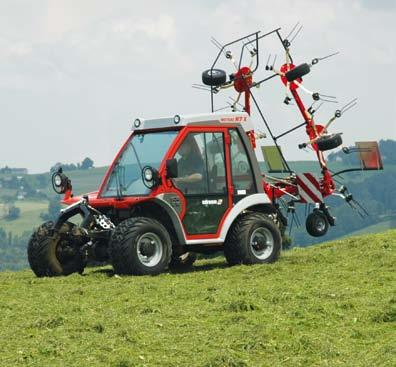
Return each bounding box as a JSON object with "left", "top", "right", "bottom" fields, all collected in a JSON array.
[{"left": 27, "top": 222, "right": 85, "bottom": 277}]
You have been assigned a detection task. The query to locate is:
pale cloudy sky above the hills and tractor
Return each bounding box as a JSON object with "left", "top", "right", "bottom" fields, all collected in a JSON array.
[{"left": 0, "top": 0, "right": 396, "bottom": 173}]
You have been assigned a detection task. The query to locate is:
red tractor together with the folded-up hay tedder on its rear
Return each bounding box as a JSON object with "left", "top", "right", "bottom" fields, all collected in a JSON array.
[{"left": 28, "top": 26, "right": 382, "bottom": 277}]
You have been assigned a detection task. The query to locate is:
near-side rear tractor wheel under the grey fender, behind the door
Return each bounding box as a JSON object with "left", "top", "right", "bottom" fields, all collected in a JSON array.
[{"left": 224, "top": 212, "right": 282, "bottom": 265}]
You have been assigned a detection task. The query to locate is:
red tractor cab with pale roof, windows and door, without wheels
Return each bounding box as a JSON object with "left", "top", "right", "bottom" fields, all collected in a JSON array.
[{"left": 60, "top": 113, "right": 269, "bottom": 242}]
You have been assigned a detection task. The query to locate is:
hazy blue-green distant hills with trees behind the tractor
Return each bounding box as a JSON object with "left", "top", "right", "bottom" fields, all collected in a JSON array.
[{"left": 0, "top": 157, "right": 396, "bottom": 270}]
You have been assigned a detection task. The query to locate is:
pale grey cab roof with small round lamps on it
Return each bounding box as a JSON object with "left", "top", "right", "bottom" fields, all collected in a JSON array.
[{"left": 132, "top": 112, "right": 253, "bottom": 131}]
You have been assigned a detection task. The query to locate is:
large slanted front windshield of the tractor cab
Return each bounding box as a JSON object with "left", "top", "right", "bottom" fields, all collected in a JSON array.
[{"left": 101, "top": 131, "right": 178, "bottom": 197}]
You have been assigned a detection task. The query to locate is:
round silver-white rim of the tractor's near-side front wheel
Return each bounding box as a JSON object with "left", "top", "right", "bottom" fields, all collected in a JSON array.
[{"left": 136, "top": 232, "right": 163, "bottom": 268}]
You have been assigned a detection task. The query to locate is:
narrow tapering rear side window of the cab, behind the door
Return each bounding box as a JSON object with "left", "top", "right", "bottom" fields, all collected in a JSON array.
[{"left": 230, "top": 129, "right": 257, "bottom": 195}]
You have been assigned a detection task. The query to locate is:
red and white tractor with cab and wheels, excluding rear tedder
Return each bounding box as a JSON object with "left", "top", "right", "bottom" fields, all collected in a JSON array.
[{"left": 28, "top": 112, "right": 286, "bottom": 276}]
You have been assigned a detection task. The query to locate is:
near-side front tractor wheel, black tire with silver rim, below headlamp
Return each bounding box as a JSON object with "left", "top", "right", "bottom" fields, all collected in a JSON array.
[{"left": 110, "top": 217, "right": 172, "bottom": 275}]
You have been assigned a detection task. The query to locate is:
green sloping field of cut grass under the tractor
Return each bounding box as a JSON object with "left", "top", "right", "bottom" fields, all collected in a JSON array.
[{"left": 0, "top": 230, "right": 396, "bottom": 367}]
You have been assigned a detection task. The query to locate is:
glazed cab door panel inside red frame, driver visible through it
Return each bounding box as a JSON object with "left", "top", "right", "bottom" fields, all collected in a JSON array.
[{"left": 173, "top": 128, "right": 230, "bottom": 235}]
